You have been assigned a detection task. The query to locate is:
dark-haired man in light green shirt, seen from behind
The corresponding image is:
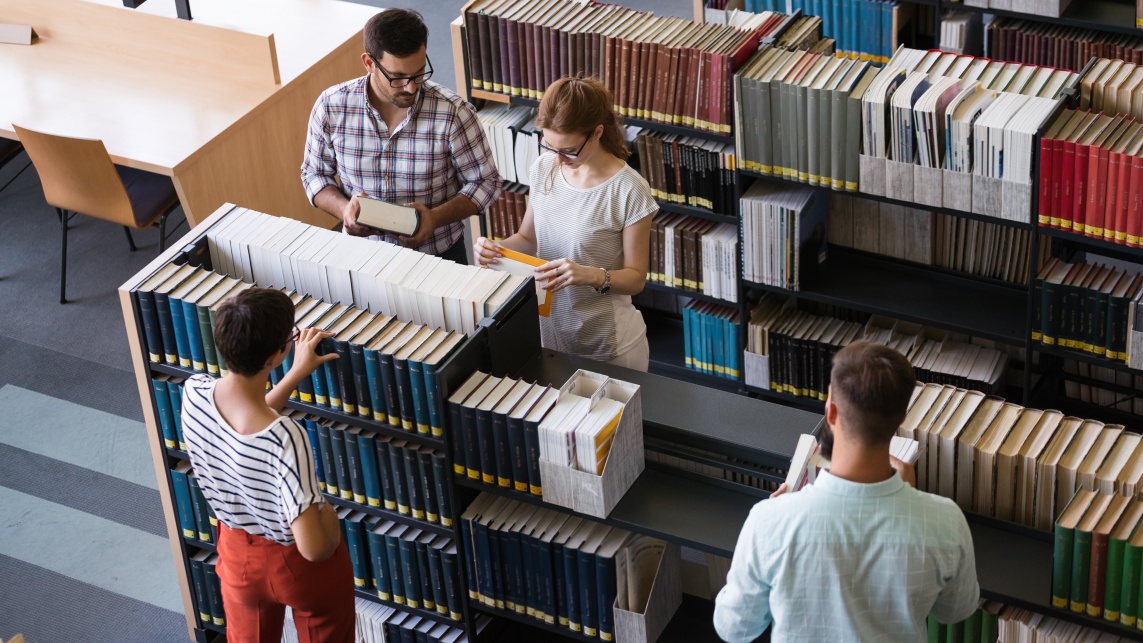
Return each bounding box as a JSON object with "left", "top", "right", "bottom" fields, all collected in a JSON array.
[{"left": 714, "top": 341, "right": 980, "bottom": 643}]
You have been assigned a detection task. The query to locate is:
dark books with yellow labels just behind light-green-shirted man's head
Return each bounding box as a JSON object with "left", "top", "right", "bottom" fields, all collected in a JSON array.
[{"left": 746, "top": 292, "right": 1007, "bottom": 401}]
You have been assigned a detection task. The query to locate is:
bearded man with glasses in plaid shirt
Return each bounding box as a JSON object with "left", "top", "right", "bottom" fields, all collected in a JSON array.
[{"left": 302, "top": 9, "right": 501, "bottom": 263}]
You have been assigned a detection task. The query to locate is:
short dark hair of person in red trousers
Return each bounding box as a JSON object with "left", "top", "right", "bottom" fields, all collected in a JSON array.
[{"left": 215, "top": 288, "right": 294, "bottom": 376}]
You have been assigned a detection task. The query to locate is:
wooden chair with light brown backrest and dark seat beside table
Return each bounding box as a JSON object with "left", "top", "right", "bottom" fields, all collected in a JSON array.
[{"left": 13, "top": 124, "right": 178, "bottom": 304}]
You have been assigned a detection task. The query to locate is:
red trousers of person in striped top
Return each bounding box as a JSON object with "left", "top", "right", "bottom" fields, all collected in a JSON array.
[{"left": 218, "top": 522, "right": 357, "bottom": 643}]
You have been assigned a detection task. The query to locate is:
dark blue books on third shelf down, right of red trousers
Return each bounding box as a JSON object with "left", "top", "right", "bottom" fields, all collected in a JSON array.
[{"left": 337, "top": 507, "right": 463, "bottom": 621}]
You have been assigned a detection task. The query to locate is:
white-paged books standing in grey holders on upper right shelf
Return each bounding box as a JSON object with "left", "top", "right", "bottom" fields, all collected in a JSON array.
[{"left": 862, "top": 48, "right": 1076, "bottom": 184}]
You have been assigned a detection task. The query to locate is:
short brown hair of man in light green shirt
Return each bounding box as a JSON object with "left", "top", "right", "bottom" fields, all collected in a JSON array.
[{"left": 830, "top": 340, "right": 917, "bottom": 445}]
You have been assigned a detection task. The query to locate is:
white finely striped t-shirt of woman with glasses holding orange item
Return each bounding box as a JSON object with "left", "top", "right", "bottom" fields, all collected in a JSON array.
[{"left": 530, "top": 152, "right": 658, "bottom": 361}]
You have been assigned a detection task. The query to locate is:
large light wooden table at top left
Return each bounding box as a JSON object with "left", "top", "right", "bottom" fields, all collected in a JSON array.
[{"left": 0, "top": 0, "right": 378, "bottom": 227}]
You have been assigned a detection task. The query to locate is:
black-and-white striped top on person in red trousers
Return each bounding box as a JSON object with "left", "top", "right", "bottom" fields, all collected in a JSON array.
[{"left": 182, "top": 375, "right": 321, "bottom": 545}]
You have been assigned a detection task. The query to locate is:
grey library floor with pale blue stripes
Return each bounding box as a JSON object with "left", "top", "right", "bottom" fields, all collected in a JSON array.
[{"left": 0, "top": 0, "right": 690, "bottom": 643}]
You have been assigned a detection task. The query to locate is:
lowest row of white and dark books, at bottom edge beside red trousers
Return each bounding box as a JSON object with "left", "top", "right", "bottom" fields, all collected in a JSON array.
[{"left": 282, "top": 596, "right": 490, "bottom": 643}]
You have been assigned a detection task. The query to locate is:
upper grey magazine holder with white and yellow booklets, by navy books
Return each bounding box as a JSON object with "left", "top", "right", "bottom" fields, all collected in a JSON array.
[{"left": 539, "top": 370, "right": 644, "bottom": 519}]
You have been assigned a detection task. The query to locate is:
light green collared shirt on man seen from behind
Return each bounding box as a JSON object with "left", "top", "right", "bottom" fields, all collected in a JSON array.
[{"left": 714, "top": 472, "right": 980, "bottom": 643}]
